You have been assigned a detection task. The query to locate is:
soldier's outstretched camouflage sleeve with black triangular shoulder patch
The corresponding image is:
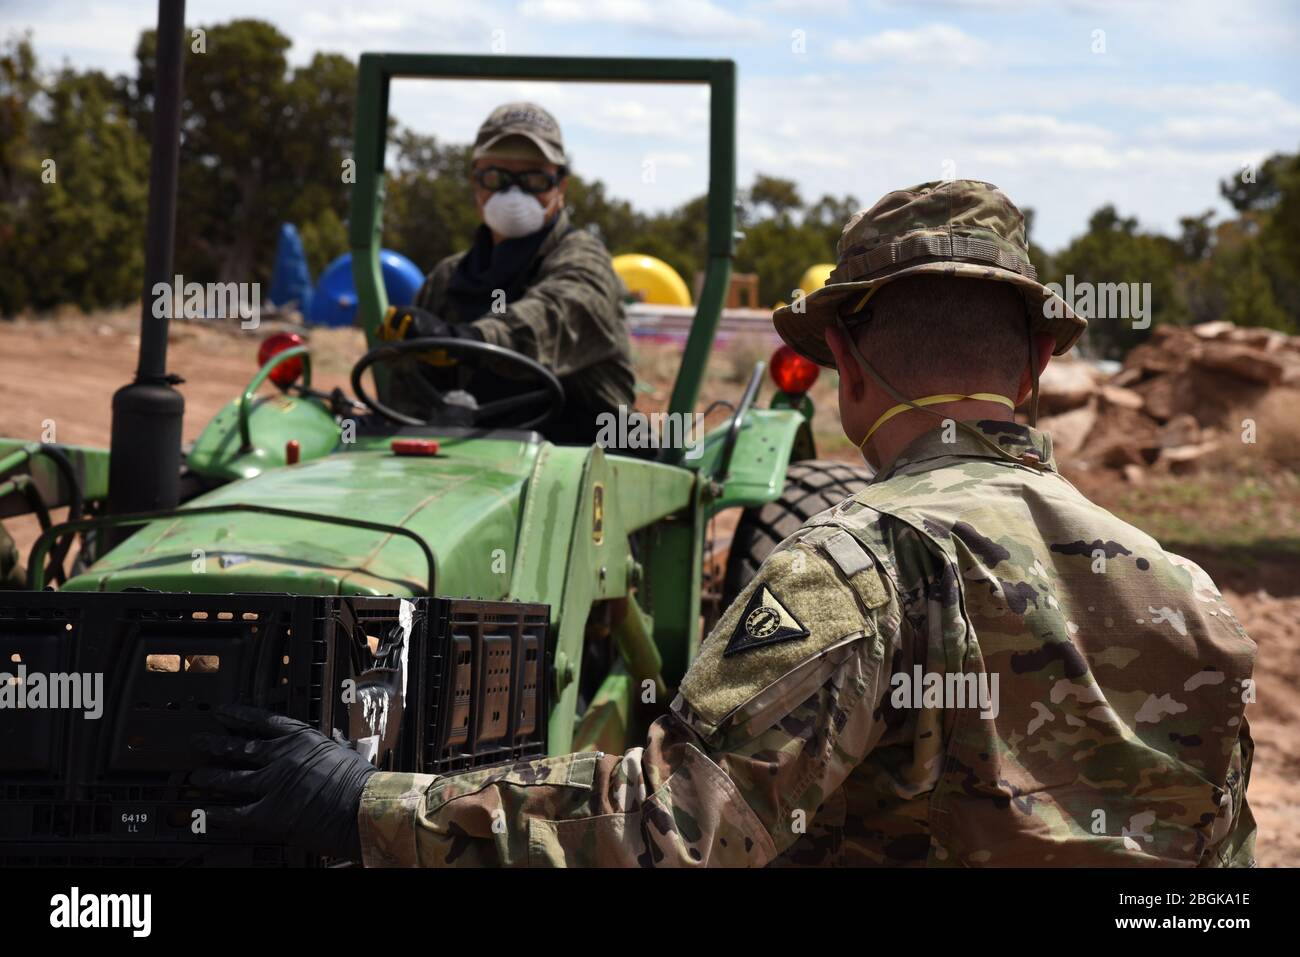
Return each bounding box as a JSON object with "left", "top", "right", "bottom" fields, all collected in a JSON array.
[{"left": 359, "top": 530, "right": 900, "bottom": 867}]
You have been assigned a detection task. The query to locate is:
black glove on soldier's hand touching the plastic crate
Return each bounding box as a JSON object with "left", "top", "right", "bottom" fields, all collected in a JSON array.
[{"left": 190, "top": 705, "right": 374, "bottom": 861}]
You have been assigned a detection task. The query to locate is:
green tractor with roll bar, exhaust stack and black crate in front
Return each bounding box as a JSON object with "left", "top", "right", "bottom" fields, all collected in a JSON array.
[{"left": 0, "top": 18, "right": 870, "bottom": 863}]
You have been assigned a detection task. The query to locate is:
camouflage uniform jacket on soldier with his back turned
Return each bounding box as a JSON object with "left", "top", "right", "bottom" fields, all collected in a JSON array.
[{"left": 360, "top": 421, "right": 1255, "bottom": 866}]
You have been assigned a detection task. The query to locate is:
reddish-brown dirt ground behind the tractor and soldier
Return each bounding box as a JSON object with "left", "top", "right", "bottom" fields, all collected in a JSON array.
[{"left": 0, "top": 311, "right": 1300, "bottom": 866}]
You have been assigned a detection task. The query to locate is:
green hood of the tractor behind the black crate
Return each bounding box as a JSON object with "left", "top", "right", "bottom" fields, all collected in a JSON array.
[{"left": 65, "top": 438, "right": 542, "bottom": 598}]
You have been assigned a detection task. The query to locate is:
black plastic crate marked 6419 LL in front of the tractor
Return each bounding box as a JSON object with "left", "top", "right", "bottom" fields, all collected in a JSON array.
[{"left": 0, "top": 592, "right": 549, "bottom": 866}]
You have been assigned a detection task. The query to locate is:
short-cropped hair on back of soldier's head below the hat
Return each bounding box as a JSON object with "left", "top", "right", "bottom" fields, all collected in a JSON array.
[{"left": 846, "top": 276, "right": 1030, "bottom": 399}]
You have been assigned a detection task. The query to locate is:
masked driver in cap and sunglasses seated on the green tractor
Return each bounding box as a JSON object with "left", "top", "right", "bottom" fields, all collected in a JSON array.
[{"left": 380, "top": 103, "right": 636, "bottom": 443}]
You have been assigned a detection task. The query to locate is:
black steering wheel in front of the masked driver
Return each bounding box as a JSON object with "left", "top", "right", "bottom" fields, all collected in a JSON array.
[{"left": 352, "top": 337, "right": 564, "bottom": 429}]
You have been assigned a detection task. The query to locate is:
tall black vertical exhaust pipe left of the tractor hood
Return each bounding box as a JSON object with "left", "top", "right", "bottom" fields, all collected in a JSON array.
[{"left": 108, "top": 0, "right": 185, "bottom": 545}]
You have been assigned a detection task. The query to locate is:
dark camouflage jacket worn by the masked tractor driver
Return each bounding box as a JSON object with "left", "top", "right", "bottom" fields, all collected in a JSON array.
[{"left": 415, "top": 209, "right": 636, "bottom": 408}]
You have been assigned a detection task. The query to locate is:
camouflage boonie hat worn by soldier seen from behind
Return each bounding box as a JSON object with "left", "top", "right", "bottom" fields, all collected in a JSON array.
[{"left": 772, "top": 179, "right": 1088, "bottom": 368}]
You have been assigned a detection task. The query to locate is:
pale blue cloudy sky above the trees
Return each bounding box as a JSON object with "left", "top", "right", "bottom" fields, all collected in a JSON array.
[{"left": 10, "top": 0, "right": 1300, "bottom": 248}]
